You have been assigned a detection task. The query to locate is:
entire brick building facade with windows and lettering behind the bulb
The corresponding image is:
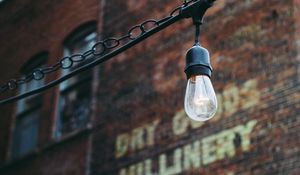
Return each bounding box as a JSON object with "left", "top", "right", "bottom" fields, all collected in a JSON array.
[{"left": 0, "top": 0, "right": 300, "bottom": 175}]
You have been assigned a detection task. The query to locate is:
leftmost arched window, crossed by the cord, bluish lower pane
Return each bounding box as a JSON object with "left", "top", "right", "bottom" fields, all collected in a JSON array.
[{"left": 12, "top": 54, "right": 47, "bottom": 158}]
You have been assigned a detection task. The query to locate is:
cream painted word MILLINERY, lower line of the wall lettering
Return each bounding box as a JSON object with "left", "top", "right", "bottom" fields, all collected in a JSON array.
[{"left": 119, "top": 120, "right": 257, "bottom": 175}]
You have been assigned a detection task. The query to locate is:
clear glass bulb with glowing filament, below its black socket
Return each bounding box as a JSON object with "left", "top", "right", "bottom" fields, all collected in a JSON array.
[{"left": 184, "top": 75, "right": 217, "bottom": 121}]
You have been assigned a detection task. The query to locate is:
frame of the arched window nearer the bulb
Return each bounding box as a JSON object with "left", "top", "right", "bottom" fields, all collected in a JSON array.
[{"left": 54, "top": 22, "right": 97, "bottom": 139}]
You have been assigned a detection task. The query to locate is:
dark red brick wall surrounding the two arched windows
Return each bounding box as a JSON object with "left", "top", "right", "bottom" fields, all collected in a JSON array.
[{"left": 0, "top": 0, "right": 100, "bottom": 175}]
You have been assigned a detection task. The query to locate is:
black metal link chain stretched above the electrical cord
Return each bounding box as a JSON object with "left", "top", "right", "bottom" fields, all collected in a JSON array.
[{"left": 0, "top": 0, "right": 195, "bottom": 93}]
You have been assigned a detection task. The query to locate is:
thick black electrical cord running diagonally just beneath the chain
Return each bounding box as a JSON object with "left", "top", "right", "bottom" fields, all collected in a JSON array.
[{"left": 0, "top": 0, "right": 216, "bottom": 105}]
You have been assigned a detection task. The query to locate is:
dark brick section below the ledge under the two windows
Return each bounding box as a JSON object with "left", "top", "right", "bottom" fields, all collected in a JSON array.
[{"left": 1, "top": 134, "right": 88, "bottom": 175}]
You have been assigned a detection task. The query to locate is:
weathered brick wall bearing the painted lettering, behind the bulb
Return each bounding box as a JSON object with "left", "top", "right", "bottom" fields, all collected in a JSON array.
[{"left": 92, "top": 0, "right": 300, "bottom": 175}]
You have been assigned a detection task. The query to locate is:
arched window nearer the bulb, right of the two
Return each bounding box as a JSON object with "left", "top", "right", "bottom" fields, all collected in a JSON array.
[{"left": 56, "top": 25, "right": 96, "bottom": 137}]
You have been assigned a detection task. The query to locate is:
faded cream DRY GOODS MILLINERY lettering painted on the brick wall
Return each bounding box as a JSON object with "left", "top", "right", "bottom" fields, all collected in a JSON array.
[{"left": 115, "top": 79, "right": 260, "bottom": 175}]
